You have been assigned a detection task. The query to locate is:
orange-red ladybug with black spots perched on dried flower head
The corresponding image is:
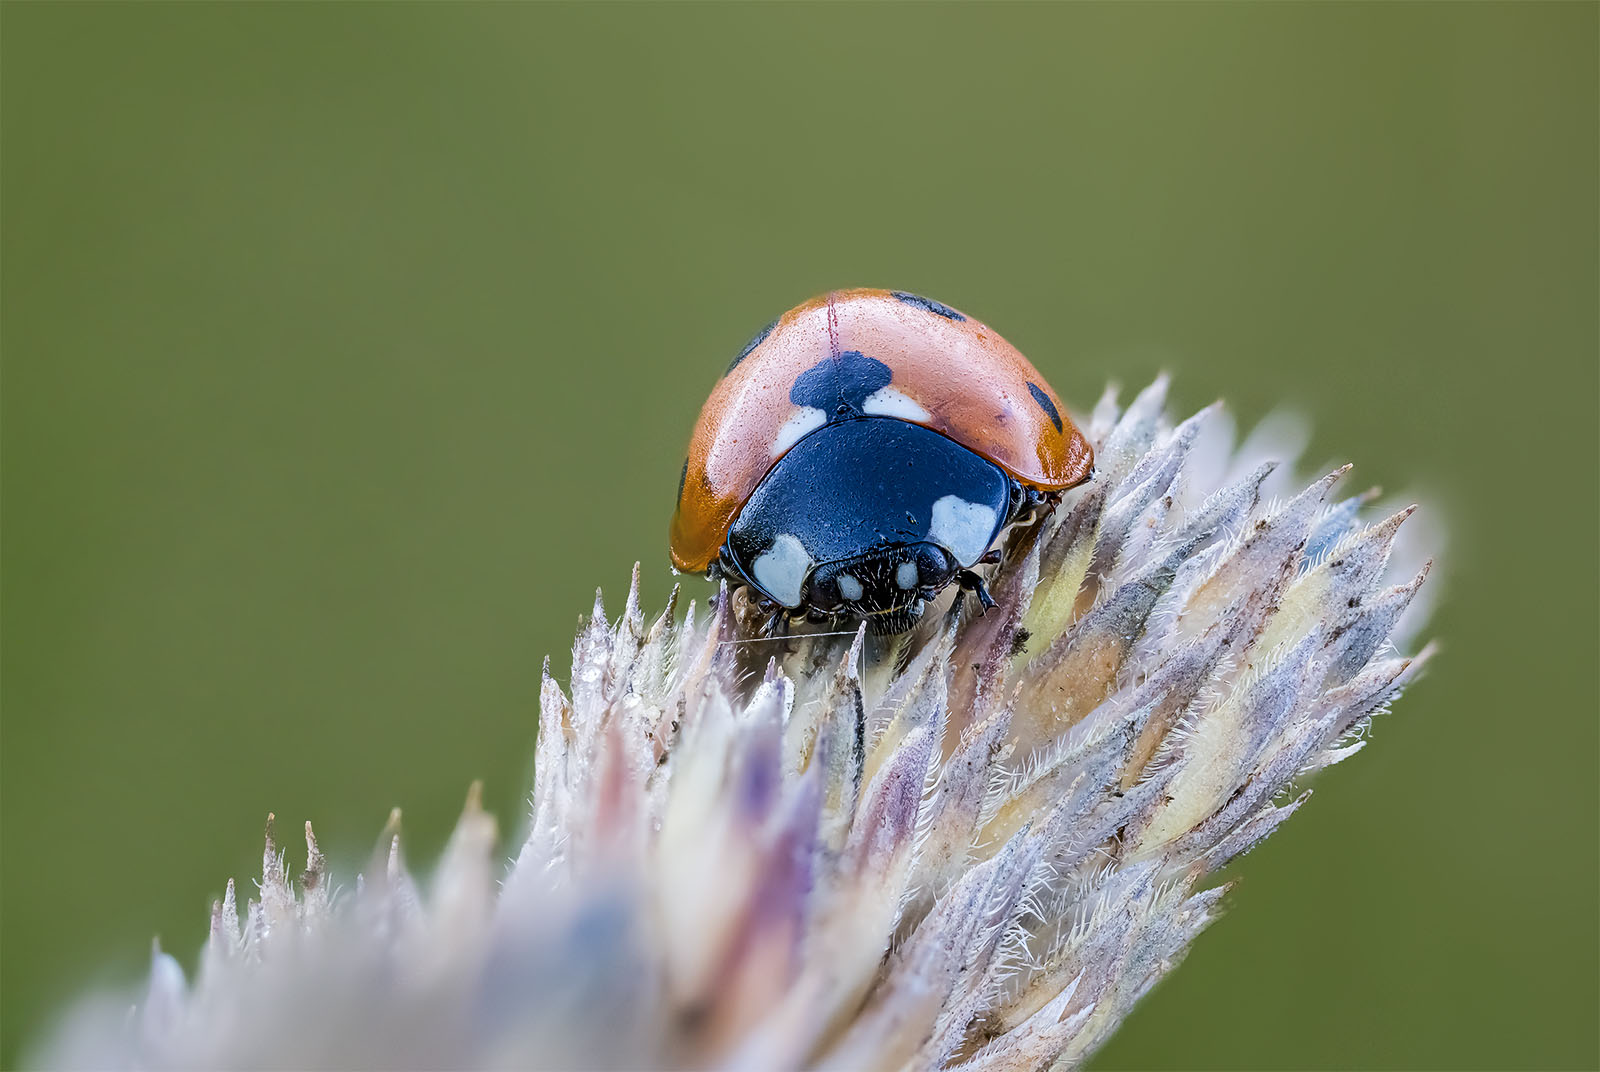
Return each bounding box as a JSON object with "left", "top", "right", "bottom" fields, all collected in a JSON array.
[{"left": 672, "top": 290, "right": 1094, "bottom": 634}]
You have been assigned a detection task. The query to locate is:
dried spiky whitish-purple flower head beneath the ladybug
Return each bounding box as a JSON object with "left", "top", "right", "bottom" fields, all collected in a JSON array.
[{"left": 42, "top": 382, "right": 1427, "bottom": 1072}]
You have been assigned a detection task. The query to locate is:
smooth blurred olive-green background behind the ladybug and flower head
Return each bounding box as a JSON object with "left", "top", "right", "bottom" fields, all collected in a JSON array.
[{"left": 0, "top": 3, "right": 1600, "bottom": 1069}]
